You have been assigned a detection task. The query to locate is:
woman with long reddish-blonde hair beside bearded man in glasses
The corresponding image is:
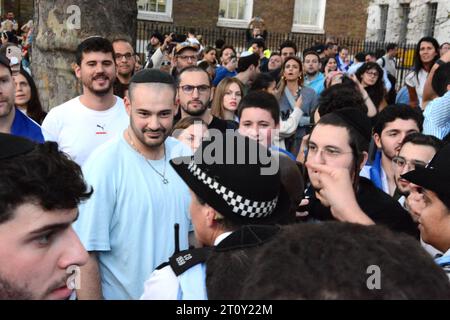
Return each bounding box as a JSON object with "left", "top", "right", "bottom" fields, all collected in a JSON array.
[{"left": 211, "top": 78, "right": 244, "bottom": 122}]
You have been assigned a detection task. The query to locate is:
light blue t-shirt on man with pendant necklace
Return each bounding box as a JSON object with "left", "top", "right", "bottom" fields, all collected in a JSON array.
[{"left": 74, "top": 135, "right": 192, "bottom": 300}]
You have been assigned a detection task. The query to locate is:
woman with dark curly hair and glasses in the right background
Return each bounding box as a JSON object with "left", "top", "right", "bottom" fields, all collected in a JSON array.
[{"left": 355, "top": 62, "right": 387, "bottom": 111}]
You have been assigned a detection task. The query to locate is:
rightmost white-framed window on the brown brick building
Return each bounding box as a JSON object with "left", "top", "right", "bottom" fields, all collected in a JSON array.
[{"left": 292, "top": 0, "right": 327, "bottom": 33}]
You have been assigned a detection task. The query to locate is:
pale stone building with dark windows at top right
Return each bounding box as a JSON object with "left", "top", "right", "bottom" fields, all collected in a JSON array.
[{"left": 367, "top": 0, "right": 450, "bottom": 43}]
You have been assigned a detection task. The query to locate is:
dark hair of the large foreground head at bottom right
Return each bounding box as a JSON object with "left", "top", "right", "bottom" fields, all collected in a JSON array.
[{"left": 240, "top": 222, "right": 450, "bottom": 300}]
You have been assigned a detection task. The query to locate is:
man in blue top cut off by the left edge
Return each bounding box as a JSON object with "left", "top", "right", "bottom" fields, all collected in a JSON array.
[{"left": 0, "top": 54, "right": 44, "bottom": 142}]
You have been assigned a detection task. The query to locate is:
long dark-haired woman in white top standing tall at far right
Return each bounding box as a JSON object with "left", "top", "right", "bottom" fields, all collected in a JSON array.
[{"left": 405, "top": 37, "right": 440, "bottom": 107}]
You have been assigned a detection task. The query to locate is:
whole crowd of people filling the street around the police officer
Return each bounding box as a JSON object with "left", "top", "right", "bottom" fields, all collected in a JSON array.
[{"left": 0, "top": 15, "right": 450, "bottom": 300}]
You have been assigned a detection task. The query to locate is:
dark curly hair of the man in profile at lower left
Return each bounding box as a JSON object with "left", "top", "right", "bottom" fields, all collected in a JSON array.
[{"left": 0, "top": 142, "right": 93, "bottom": 223}]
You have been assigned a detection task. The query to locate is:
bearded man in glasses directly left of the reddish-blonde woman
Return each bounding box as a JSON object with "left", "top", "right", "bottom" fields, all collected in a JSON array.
[{"left": 177, "top": 66, "right": 237, "bottom": 133}]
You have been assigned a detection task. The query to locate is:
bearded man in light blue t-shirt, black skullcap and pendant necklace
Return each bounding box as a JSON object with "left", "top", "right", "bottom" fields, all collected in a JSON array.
[{"left": 75, "top": 69, "right": 192, "bottom": 299}]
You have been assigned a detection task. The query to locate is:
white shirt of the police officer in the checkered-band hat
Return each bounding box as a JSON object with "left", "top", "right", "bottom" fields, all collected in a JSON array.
[{"left": 140, "top": 232, "right": 232, "bottom": 300}]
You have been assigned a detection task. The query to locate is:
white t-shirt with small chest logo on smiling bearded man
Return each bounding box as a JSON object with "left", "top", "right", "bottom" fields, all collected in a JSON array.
[{"left": 42, "top": 97, "right": 130, "bottom": 166}]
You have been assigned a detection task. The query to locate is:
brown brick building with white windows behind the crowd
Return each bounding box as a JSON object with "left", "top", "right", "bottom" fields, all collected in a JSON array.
[{"left": 138, "top": 0, "right": 369, "bottom": 39}]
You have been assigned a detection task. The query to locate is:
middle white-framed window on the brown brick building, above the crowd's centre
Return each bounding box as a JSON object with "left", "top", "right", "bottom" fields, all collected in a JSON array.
[{"left": 217, "top": 0, "right": 253, "bottom": 28}]
